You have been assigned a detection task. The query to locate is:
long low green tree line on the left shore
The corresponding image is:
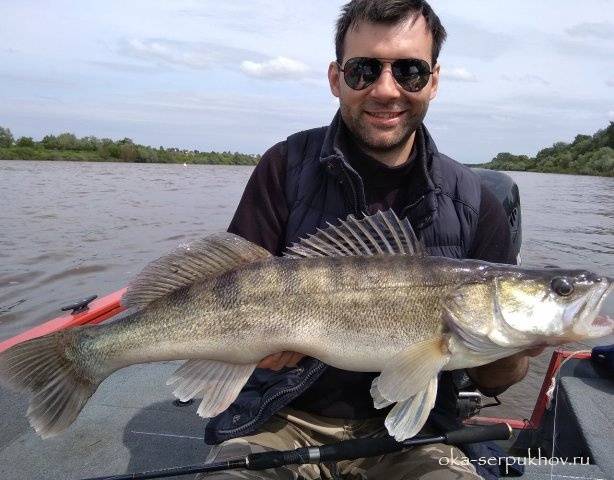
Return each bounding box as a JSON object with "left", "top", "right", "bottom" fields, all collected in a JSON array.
[{"left": 0, "top": 127, "right": 260, "bottom": 165}]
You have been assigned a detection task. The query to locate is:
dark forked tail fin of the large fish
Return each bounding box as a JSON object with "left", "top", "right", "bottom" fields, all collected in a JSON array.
[{"left": 0, "top": 331, "right": 100, "bottom": 438}]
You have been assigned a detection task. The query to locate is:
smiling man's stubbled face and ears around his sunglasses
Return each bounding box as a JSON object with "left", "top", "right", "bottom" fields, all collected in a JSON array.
[{"left": 328, "top": 16, "right": 439, "bottom": 152}]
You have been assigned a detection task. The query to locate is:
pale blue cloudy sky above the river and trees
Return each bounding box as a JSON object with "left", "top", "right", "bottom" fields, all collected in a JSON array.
[{"left": 0, "top": 0, "right": 614, "bottom": 163}]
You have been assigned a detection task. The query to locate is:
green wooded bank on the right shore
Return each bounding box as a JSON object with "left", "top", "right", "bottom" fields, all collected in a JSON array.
[{"left": 482, "top": 122, "right": 614, "bottom": 177}]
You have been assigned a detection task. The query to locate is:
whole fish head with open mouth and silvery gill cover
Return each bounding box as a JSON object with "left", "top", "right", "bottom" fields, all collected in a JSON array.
[{"left": 446, "top": 264, "right": 614, "bottom": 350}]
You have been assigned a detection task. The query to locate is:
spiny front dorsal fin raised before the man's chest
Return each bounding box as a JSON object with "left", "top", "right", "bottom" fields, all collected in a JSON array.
[{"left": 284, "top": 210, "right": 426, "bottom": 258}]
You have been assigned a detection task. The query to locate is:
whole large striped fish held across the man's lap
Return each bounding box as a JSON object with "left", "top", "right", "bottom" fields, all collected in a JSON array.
[{"left": 0, "top": 212, "right": 614, "bottom": 440}]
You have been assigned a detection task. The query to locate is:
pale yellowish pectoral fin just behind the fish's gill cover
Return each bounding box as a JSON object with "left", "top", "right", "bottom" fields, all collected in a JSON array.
[{"left": 372, "top": 337, "right": 450, "bottom": 403}]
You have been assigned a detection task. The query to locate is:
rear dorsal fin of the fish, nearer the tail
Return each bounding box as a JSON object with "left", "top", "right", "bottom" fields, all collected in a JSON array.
[{"left": 121, "top": 232, "right": 271, "bottom": 308}]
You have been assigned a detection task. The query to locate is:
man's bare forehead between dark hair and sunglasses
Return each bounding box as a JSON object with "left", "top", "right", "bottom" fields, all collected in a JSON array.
[{"left": 344, "top": 15, "right": 433, "bottom": 60}]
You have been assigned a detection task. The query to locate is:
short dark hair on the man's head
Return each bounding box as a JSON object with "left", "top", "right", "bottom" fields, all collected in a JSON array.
[{"left": 335, "top": 0, "right": 446, "bottom": 65}]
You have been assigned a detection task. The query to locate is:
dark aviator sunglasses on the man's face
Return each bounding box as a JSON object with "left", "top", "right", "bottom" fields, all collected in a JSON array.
[{"left": 337, "top": 57, "right": 433, "bottom": 92}]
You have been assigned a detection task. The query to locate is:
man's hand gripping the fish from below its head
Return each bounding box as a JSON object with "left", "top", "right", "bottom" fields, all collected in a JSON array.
[{"left": 467, "top": 347, "right": 546, "bottom": 395}]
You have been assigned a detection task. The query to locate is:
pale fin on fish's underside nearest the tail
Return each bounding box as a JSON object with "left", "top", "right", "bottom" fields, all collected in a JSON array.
[{"left": 166, "top": 360, "right": 256, "bottom": 418}]
